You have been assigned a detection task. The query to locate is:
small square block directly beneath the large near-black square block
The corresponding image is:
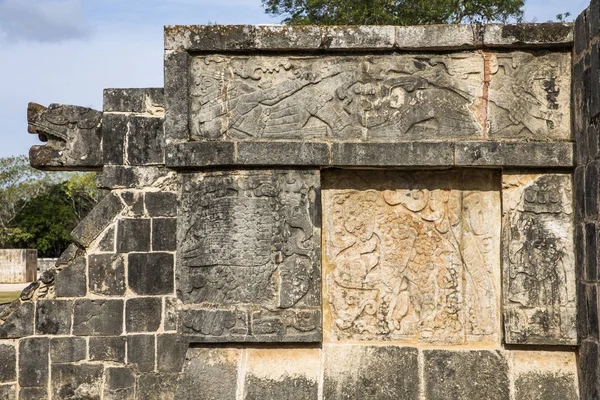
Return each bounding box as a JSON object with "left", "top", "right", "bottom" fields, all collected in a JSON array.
[{"left": 125, "top": 297, "right": 162, "bottom": 332}]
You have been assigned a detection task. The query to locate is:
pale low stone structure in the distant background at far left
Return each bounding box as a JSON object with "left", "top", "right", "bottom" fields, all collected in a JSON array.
[{"left": 0, "top": 249, "right": 37, "bottom": 283}]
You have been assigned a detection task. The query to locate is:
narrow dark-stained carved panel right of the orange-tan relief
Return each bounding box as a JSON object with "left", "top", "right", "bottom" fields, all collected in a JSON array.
[{"left": 502, "top": 173, "right": 577, "bottom": 345}]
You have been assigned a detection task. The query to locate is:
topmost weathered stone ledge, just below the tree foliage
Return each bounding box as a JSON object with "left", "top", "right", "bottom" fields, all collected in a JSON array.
[{"left": 164, "top": 22, "right": 573, "bottom": 52}]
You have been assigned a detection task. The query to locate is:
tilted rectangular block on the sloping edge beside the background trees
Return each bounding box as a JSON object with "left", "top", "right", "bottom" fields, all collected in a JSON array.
[{"left": 71, "top": 193, "right": 125, "bottom": 247}]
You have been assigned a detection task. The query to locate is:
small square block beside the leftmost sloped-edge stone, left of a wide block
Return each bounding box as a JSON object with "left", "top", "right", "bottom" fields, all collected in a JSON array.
[{"left": 35, "top": 300, "right": 73, "bottom": 335}]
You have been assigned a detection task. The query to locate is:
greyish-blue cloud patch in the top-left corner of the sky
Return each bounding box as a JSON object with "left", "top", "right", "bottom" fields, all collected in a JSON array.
[{"left": 0, "top": 0, "right": 90, "bottom": 42}]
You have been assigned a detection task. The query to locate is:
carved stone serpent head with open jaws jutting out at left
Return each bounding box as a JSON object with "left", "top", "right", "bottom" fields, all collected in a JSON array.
[{"left": 27, "top": 103, "right": 102, "bottom": 171}]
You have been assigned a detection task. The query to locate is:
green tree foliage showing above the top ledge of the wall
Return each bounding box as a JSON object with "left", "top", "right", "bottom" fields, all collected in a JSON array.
[{"left": 262, "top": 0, "right": 525, "bottom": 25}]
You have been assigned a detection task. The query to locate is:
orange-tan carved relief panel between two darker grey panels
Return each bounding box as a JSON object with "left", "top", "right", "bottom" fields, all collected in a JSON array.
[{"left": 323, "top": 170, "right": 501, "bottom": 344}]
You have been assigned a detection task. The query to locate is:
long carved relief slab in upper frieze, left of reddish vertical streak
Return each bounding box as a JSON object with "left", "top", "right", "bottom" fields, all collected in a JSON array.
[{"left": 189, "top": 53, "right": 484, "bottom": 141}]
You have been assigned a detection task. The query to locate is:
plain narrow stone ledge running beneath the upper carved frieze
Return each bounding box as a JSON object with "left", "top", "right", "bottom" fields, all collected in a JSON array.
[{"left": 166, "top": 141, "right": 574, "bottom": 169}]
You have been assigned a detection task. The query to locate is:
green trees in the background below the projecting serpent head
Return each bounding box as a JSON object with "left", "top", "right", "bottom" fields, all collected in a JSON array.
[{"left": 0, "top": 156, "right": 104, "bottom": 257}]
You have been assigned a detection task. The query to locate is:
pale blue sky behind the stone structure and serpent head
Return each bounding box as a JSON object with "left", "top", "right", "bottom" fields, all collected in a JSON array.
[{"left": 0, "top": 0, "right": 589, "bottom": 157}]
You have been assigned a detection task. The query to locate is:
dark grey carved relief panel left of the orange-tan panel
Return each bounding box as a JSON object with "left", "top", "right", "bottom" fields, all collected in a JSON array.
[{"left": 177, "top": 171, "right": 321, "bottom": 342}]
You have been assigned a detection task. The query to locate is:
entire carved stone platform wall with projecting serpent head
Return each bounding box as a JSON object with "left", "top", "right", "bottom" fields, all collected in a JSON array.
[{"left": 0, "top": 18, "right": 584, "bottom": 400}]
